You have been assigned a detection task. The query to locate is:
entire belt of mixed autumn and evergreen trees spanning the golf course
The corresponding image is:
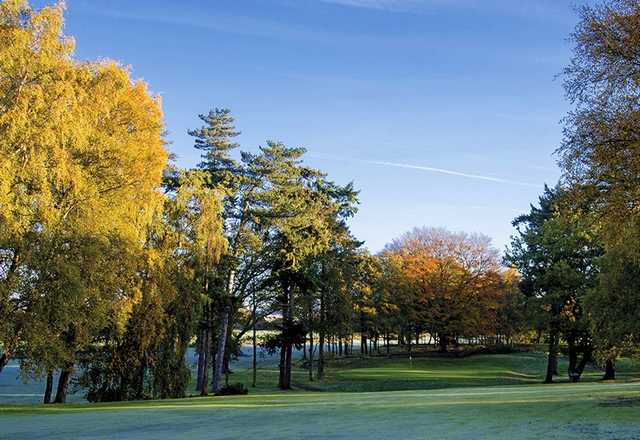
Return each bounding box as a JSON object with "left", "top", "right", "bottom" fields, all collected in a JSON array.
[{"left": 0, "top": 0, "right": 640, "bottom": 403}]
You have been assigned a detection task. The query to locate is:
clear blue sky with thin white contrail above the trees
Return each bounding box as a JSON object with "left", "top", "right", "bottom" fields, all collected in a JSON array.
[{"left": 38, "top": 0, "right": 576, "bottom": 251}]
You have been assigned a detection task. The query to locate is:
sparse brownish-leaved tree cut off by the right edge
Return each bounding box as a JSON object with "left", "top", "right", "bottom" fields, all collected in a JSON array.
[{"left": 558, "top": 0, "right": 640, "bottom": 368}]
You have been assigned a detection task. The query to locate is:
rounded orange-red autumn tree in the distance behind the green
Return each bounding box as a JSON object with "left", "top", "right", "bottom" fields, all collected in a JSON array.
[{"left": 385, "top": 228, "right": 507, "bottom": 351}]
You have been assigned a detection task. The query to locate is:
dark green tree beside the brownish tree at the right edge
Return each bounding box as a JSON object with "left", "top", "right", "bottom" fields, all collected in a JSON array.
[{"left": 505, "top": 187, "right": 602, "bottom": 382}]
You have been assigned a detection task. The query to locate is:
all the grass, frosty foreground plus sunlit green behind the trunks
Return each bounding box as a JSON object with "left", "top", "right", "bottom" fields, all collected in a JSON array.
[{"left": 0, "top": 353, "right": 640, "bottom": 440}]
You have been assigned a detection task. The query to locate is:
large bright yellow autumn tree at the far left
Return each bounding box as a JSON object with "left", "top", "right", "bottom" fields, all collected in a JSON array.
[{"left": 0, "top": 0, "right": 167, "bottom": 401}]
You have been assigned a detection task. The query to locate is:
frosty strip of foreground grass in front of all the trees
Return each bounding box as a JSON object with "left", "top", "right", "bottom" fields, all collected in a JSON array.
[{"left": 0, "top": 382, "right": 640, "bottom": 440}]
